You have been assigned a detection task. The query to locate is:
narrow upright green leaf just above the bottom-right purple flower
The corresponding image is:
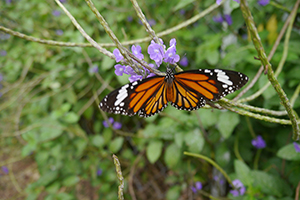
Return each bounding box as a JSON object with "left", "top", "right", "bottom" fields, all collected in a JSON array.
[{"left": 234, "top": 160, "right": 253, "bottom": 186}]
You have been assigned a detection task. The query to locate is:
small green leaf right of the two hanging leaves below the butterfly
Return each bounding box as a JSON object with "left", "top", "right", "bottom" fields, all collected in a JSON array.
[{"left": 184, "top": 128, "right": 204, "bottom": 153}]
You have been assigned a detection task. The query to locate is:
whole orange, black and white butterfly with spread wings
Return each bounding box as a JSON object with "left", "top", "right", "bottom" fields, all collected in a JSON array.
[{"left": 99, "top": 68, "right": 248, "bottom": 117}]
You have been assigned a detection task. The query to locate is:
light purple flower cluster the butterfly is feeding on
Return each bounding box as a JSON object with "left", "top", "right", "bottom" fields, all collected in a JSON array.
[{"left": 113, "top": 38, "right": 180, "bottom": 82}]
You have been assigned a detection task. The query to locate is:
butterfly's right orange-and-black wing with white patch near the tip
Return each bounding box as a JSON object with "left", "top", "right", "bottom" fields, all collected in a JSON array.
[{"left": 171, "top": 69, "right": 248, "bottom": 111}]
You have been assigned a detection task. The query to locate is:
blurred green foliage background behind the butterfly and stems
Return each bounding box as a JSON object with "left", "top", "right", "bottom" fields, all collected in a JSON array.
[{"left": 0, "top": 0, "right": 300, "bottom": 200}]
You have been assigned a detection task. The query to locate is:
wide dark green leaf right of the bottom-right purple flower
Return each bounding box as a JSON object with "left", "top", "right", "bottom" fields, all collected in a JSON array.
[{"left": 249, "top": 171, "right": 292, "bottom": 197}]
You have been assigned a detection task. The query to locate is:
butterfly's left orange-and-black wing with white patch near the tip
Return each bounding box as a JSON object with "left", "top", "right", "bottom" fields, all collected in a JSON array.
[{"left": 99, "top": 76, "right": 168, "bottom": 117}]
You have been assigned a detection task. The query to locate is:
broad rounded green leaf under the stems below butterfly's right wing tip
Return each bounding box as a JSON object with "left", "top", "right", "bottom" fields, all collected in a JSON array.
[{"left": 217, "top": 111, "right": 240, "bottom": 139}]
